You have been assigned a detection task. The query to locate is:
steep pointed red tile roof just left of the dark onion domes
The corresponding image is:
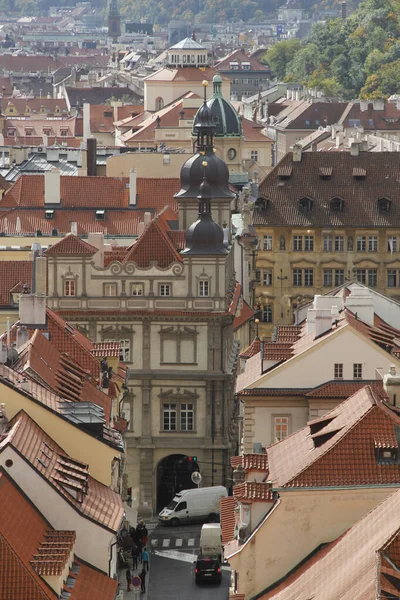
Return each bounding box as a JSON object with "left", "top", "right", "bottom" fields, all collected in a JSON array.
[{"left": 123, "top": 214, "right": 182, "bottom": 269}]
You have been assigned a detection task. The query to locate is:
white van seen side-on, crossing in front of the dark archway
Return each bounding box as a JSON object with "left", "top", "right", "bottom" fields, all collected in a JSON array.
[{"left": 158, "top": 485, "right": 228, "bottom": 526}]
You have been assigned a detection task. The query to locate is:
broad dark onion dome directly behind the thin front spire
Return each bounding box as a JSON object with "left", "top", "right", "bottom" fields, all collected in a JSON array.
[{"left": 175, "top": 151, "right": 235, "bottom": 198}]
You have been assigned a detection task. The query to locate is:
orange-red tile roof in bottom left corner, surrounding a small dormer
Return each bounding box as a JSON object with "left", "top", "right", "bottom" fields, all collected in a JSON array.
[{"left": 0, "top": 471, "right": 118, "bottom": 600}]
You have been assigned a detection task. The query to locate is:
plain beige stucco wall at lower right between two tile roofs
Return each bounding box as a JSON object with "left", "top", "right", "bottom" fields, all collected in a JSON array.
[{"left": 229, "top": 486, "right": 400, "bottom": 600}]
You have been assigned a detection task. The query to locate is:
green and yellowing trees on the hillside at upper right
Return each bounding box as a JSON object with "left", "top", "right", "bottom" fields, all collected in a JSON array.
[{"left": 264, "top": 0, "right": 400, "bottom": 99}]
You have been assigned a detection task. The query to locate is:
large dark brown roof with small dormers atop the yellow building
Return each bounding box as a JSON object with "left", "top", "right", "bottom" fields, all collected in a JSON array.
[{"left": 253, "top": 152, "right": 400, "bottom": 228}]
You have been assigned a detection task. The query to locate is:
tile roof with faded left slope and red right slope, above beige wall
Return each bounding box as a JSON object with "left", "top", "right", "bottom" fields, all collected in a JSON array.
[{"left": 267, "top": 386, "right": 400, "bottom": 488}]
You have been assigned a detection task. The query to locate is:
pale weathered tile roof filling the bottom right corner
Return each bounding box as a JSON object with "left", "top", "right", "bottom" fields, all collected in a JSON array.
[{"left": 259, "top": 491, "right": 400, "bottom": 600}]
